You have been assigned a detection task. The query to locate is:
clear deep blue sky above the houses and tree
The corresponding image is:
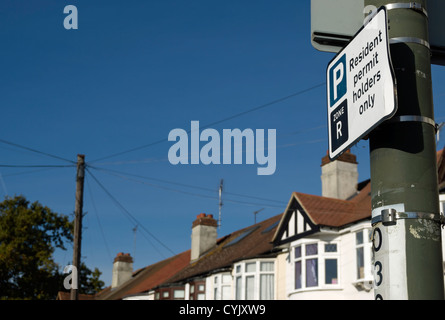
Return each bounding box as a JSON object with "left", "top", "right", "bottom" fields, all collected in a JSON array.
[{"left": 0, "top": 0, "right": 445, "bottom": 285}]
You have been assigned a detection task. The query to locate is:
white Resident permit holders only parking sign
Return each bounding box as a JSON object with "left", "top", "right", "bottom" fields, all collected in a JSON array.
[{"left": 326, "top": 7, "right": 397, "bottom": 160}]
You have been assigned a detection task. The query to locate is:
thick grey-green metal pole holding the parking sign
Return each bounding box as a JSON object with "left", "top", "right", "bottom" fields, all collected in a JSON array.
[{"left": 365, "top": 0, "right": 444, "bottom": 300}]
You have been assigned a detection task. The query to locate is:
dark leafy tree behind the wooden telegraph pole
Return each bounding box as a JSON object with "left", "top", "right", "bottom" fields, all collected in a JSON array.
[{"left": 0, "top": 196, "right": 103, "bottom": 299}]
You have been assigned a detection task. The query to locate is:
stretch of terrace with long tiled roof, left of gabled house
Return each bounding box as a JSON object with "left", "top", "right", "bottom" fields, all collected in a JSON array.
[{"left": 96, "top": 213, "right": 281, "bottom": 300}]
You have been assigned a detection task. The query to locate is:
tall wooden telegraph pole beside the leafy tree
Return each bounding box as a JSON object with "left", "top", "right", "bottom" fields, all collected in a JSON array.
[{"left": 70, "top": 154, "right": 85, "bottom": 300}]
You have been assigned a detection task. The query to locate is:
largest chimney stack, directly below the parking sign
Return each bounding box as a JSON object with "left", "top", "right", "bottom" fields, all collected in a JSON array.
[{"left": 321, "top": 150, "right": 358, "bottom": 200}]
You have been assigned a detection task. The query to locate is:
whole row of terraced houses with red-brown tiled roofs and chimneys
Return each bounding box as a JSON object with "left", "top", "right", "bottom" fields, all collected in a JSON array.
[{"left": 59, "top": 151, "right": 445, "bottom": 300}]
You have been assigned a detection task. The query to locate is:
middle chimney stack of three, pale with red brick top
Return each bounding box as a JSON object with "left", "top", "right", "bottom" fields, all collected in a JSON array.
[{"left": 190, "top": 213, "right": 218, "bottom": 261}]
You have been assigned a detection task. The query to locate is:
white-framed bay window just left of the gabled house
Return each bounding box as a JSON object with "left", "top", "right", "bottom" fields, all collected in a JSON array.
[{"left": 235, "top": 260, "right": 275, "bottom": 300}]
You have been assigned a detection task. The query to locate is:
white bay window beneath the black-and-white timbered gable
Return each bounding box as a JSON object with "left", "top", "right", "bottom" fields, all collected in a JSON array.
[{"left": 293, "top": 241, "right": 338, "bottom": 290}]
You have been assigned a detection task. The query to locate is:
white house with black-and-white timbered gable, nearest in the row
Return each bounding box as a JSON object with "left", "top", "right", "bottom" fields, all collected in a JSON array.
[{"left": 272, "top": 152, "right": 374, "bottom": 300}]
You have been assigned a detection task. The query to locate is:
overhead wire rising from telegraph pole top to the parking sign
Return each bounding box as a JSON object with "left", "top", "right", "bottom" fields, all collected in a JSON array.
[{"left": 89, "top": 82, "right": 326, "bottom": 163}]
